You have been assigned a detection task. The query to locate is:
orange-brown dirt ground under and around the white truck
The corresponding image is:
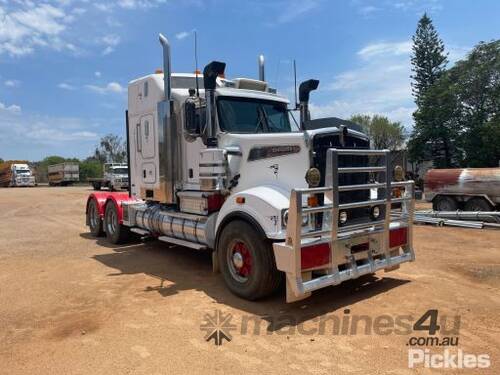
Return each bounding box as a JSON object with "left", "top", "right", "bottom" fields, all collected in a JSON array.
[{"left": 0, "top": 187, "right": 500, "bottom": 374}]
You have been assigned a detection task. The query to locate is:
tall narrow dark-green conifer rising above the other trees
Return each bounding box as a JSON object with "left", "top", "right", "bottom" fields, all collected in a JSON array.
[{"left": 409, "top": 14, "right": 454, "bottom": 166}]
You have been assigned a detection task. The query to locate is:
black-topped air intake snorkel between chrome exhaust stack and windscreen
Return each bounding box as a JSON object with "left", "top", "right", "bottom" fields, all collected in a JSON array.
[{"left": 203, "top": 61, "right": 226, "bottom": 148}]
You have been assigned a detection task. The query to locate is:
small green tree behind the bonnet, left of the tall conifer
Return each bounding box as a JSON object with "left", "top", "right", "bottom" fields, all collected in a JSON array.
[{"left": 350, "top": 114, "right": 405, "bottom": 151}]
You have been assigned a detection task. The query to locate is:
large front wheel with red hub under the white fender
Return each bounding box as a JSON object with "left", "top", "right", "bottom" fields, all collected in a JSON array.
[{"left": 217, "top": 220, "right": 281, "bottom": 300}]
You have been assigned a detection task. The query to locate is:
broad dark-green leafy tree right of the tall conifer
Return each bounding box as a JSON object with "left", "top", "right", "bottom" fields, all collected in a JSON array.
[{"left": 409, "top": 40, "right": 500, "bottom": 167}]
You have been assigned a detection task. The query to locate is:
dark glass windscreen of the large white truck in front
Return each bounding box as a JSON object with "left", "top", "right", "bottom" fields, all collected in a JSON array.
[{"left": 217, "top": 97, "right": 292, "bottom": 133}]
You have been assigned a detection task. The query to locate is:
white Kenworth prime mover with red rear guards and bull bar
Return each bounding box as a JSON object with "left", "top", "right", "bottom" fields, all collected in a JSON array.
[{"left": 86, "top": 34, "right": 415, "bottom": 302}]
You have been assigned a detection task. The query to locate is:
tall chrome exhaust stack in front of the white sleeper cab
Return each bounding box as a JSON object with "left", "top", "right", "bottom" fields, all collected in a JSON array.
[{"left": 158, "top": 34, "right": 178, "bottom": 204}]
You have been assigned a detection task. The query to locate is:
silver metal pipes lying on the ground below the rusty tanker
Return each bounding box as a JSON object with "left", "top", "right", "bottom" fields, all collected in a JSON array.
[{"left": 414, "top": 211, "right": 500, "bottom": 229}]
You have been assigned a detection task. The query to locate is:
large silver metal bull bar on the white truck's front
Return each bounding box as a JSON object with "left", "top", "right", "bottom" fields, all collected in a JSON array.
[{"left": 273, "top": 148, "right": 415, "bottom": 302}]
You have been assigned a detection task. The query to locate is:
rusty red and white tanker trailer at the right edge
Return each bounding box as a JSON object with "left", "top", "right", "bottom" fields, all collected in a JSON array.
[{"left": 424, "top": 168, "right": 500, "bottom": 211}]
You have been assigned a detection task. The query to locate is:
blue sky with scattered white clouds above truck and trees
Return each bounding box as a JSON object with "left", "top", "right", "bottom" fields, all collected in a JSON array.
[{"left": 0, "top": 0, "right": 500, "bottom": 160}]
